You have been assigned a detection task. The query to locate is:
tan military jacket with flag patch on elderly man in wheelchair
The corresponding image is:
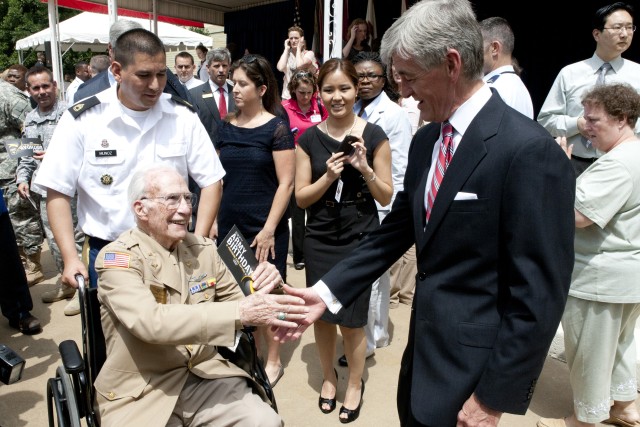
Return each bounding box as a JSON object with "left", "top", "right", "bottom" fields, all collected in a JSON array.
[{"left": 95, "top": 228, "right": 272, "bottom": 427}]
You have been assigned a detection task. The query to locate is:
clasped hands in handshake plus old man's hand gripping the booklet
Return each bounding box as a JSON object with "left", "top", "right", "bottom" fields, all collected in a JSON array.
[{"left": 239, "top": 261, "right": 326, "bottom": 342}]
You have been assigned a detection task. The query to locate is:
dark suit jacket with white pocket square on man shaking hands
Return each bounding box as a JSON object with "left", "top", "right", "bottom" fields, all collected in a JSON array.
[{"left": 323, "top": 92, "right": 575, "bottom": 427}]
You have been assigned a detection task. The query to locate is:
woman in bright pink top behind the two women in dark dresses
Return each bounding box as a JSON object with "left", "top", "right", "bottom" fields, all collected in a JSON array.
[{"left": 282, "top": 69, "right": 329, "bottom": 270}]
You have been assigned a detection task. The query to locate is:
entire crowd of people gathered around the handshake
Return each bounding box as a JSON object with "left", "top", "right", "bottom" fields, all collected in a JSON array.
[{"left": 0, "top": 0, "right": 640, "bottom": 427}]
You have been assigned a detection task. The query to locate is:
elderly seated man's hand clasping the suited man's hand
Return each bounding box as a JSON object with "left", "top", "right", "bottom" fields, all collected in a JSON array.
[{"left": 239, "top": 293, "right": 309, "bottom": 329}]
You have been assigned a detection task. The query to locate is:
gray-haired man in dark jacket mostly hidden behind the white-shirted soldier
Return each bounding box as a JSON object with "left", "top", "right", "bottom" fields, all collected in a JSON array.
[{"left": 75, "top": 19, "right": 191, "bottom": 103}]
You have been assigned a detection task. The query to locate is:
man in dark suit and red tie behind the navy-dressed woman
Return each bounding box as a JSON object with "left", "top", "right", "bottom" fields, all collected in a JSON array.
[{"left": 189, "top": 48, "right": 236, "bottom": 142}]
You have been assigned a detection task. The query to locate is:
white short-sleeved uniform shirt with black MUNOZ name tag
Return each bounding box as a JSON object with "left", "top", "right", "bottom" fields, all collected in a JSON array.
[{"left": 35, "top": 86, "right": 224, "bottom": 241}]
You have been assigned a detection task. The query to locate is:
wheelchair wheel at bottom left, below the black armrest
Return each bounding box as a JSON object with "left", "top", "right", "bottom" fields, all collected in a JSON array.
[{"left": 47, "top": 366, "right": 81, "bottom": 427}]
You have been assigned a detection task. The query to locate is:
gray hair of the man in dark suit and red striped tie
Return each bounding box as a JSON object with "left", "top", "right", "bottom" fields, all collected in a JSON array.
[{"left": 380, "top": 0, "right": 484, "bottom": 80}]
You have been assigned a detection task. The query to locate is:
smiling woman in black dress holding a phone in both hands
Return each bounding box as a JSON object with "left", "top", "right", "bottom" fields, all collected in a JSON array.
[{"left": 295, "top": 59, "right": 393, "bottom": 423}]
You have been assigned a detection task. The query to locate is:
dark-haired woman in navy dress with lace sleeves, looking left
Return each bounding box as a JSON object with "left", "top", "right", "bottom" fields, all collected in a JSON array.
[{"left": 215, "top": 55, "right": 295, "bottom": 386}]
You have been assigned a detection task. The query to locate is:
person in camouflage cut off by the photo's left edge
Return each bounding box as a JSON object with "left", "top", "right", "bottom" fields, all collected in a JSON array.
[{"left": 0, "top": 81, "right": 44, "bottom": 286}]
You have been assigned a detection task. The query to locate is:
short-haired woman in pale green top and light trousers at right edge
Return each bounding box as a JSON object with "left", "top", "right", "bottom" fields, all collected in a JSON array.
[{"left": 538, "top": 84, "right": 640, "bottom": 427}]
